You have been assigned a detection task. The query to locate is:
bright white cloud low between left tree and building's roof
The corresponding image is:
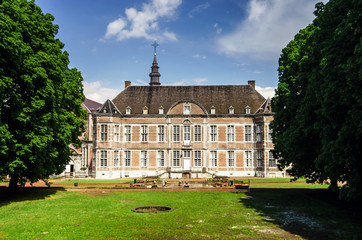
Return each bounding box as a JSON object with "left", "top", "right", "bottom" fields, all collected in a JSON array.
[{"left": 83, "top": 81, "right": 121, "bottom": 104}]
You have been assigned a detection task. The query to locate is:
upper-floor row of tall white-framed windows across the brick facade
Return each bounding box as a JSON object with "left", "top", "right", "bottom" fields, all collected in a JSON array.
[{"left": 100, "top": 124, "right": 272, "bottom": 142}]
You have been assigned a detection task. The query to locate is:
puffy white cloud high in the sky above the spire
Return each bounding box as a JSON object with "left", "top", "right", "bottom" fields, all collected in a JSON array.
[{"left": 104, "top": 0, "right": 182, "bottom": 41}]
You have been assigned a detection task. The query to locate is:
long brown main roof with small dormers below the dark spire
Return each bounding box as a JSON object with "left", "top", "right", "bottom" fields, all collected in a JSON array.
[{"left": 112, "top": 85, "right": 265, "bottom": 114}]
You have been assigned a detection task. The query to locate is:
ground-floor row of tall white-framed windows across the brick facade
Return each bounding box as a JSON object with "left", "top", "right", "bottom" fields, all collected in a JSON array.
[{"left": 98, "top": 150, "right": 276, "bottom": 168}]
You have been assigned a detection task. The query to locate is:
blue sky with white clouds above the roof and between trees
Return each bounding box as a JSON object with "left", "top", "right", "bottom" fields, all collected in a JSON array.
[{"left": 35, "top": 0, "right": 326, "bottom": 103}]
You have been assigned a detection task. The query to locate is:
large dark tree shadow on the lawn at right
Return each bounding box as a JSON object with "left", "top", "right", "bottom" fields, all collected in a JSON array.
[{"left": 240, "top": 189, "right": 362, "bottom": 240}]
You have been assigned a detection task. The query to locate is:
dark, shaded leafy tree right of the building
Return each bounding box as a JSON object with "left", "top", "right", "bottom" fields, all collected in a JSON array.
[{"left": 272, "top": 0, "right": 362, "bottom": 199}]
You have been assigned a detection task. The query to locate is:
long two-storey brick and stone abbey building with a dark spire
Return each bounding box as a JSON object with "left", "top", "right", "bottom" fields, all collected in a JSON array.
[{"left": 65, "top": 55, "right": 285, "bottom": 179}]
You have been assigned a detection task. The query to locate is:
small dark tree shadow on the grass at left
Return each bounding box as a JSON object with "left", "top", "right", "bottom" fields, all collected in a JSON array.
[{"left": 0, "top": 187, "right": 65, "bottom": 207}]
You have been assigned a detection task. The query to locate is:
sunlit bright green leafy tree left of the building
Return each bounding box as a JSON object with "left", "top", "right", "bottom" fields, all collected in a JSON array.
[{"left": 0, "top": 0, "right": 85, "bottom": 187}]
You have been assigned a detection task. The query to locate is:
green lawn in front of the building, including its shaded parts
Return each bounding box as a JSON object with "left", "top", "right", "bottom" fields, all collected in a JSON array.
[{"left": 0, "top": 188, "right": 362, "bottom": 239}]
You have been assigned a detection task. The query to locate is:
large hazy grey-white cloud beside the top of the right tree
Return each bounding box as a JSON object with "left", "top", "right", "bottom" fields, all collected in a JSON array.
[{"left": 217, "top": 0, "right": 320, "bottom": 60}]
